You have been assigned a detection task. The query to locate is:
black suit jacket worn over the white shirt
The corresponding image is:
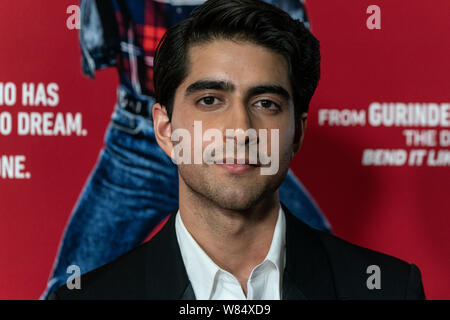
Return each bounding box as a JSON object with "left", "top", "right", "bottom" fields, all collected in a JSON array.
[{"left": 49, "top": 206, "right": 425, "bottom": 300}]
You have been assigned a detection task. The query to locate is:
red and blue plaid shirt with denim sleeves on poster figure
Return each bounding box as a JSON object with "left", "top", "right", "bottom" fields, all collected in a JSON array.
[{"left": 80, "top": 0, "right": 309, "bottom": 95}]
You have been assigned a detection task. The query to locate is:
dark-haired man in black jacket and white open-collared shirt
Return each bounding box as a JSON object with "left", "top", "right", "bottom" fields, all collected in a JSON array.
[{"left": 50, "top": 0, "right": 424, "bottom": 299}]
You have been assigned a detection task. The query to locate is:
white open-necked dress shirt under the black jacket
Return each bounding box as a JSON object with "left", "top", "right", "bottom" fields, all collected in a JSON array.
[{"left": 175, "top": 207, "right": 286, "bottom": 300}]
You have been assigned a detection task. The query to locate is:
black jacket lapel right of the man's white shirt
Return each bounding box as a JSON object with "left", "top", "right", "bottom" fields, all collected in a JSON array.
[{"left": 281, "top": 204, "right": 336, "bottom": 300}]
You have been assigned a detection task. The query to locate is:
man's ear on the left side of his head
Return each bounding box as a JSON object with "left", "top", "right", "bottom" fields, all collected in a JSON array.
[{"left": 152, "top": 103, "right": 173, "bottom": 157}]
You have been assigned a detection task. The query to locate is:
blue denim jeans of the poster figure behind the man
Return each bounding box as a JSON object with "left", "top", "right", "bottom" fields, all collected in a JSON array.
[{"left": 42, "top": 89, "right": 331, "bottom": 299}]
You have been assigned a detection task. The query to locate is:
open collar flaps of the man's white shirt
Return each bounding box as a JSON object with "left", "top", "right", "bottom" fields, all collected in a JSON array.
[{"left": 175, "top": 206, "right": 286, "bottom": 300}]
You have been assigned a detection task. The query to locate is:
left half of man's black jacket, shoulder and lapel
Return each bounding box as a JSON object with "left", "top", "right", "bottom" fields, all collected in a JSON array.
[{"left": 49, "top": 213, "right": 189, "bottom": 300}]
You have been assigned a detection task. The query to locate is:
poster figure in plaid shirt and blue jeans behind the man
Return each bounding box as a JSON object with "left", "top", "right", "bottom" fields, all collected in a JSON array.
[{"left": 43, "top": 0, "right": 331, "bottom": 298}]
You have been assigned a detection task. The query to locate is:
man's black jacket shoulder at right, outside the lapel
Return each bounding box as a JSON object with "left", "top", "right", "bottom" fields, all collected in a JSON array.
[{"left": 292, "top": 218, "right": 425, "bottom": 299}]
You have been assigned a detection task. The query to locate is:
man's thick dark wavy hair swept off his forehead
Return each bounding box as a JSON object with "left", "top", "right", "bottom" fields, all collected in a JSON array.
[{"left": 154, "top": 0, "right": 320, "bottom": 124}]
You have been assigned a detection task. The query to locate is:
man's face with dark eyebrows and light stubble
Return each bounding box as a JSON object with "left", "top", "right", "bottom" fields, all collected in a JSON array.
[{"left": 158, "top": 40, "right": 303, "bottom": 210}]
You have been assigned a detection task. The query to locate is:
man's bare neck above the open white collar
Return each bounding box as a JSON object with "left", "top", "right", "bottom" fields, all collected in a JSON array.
[{"left": 179, "top": 179, "right": 280, "bottom": 294}]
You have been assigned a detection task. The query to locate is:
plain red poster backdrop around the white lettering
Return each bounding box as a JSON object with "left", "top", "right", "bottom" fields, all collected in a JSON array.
[{"left": 0, "top": 0, "right": 450, "bottom": 299}]
